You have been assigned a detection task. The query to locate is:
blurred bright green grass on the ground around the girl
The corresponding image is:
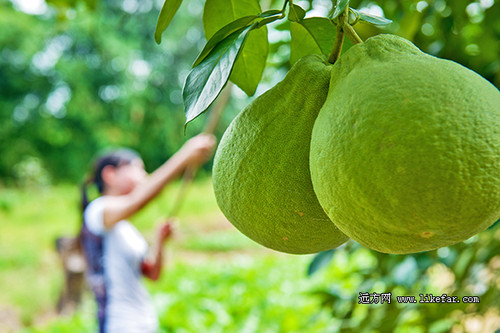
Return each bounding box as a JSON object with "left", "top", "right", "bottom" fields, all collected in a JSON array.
[{"left": 0, "top": 179, "right": 338, "bottom": 333}]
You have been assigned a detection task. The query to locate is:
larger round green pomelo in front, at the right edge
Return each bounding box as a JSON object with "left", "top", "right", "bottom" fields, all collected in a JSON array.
[{"left": 310, "top": 35, "right": 500, "bottom": 253}]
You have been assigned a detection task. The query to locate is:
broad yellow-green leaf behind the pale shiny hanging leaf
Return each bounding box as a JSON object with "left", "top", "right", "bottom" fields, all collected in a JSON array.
[{"left": 203, "top": 0, "right": 268, "bottom": 96}]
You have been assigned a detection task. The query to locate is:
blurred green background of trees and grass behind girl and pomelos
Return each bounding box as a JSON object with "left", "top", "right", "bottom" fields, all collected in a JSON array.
[{"left": 0, "top": 0, "right": 500, "bottom": 333}]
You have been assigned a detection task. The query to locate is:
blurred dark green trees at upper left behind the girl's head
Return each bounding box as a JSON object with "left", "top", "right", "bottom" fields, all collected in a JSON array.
[{"left": 0, "top": 0, "right": 219, "bottom": 182}]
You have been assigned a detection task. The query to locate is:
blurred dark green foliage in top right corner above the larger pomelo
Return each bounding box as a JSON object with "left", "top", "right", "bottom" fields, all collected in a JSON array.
[{"left": 351, "top": 0, "right": 500, "bottom": 87}]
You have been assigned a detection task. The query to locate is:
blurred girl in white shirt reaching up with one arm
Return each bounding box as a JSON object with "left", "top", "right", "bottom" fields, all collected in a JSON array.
[{"left": 81, "top": 135, "right": 215, "bottom": 333}]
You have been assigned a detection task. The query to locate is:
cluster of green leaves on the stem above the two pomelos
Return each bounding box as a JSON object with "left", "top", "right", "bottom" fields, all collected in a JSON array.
[{"left": 155, "top": 0, "right": 391, "bottom": 124}]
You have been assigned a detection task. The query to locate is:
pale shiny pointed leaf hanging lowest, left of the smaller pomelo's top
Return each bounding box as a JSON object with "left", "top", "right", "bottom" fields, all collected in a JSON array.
[{"left": 182, "top": 26, "right": 253, "bottom": 124}]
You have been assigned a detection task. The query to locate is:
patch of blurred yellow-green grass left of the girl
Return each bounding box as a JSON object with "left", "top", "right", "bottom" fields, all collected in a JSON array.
[{"left": 0, "top": 186, "right": 78, "bottom": 325}]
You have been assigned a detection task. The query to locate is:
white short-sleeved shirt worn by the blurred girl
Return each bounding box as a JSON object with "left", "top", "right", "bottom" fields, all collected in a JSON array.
[{"left": 84, "top": 196, "right": 158, "bottom": 333}]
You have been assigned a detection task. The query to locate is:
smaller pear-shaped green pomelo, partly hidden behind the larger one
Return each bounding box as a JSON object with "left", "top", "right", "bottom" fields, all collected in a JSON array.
[{"left": 213, "top": 56, "right": 348, "bottom": 254}]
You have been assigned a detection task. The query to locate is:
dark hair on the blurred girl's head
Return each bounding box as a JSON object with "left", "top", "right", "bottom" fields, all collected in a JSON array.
[{"left": 82, "top": 148, "right": 141, "bottom": 211}]
